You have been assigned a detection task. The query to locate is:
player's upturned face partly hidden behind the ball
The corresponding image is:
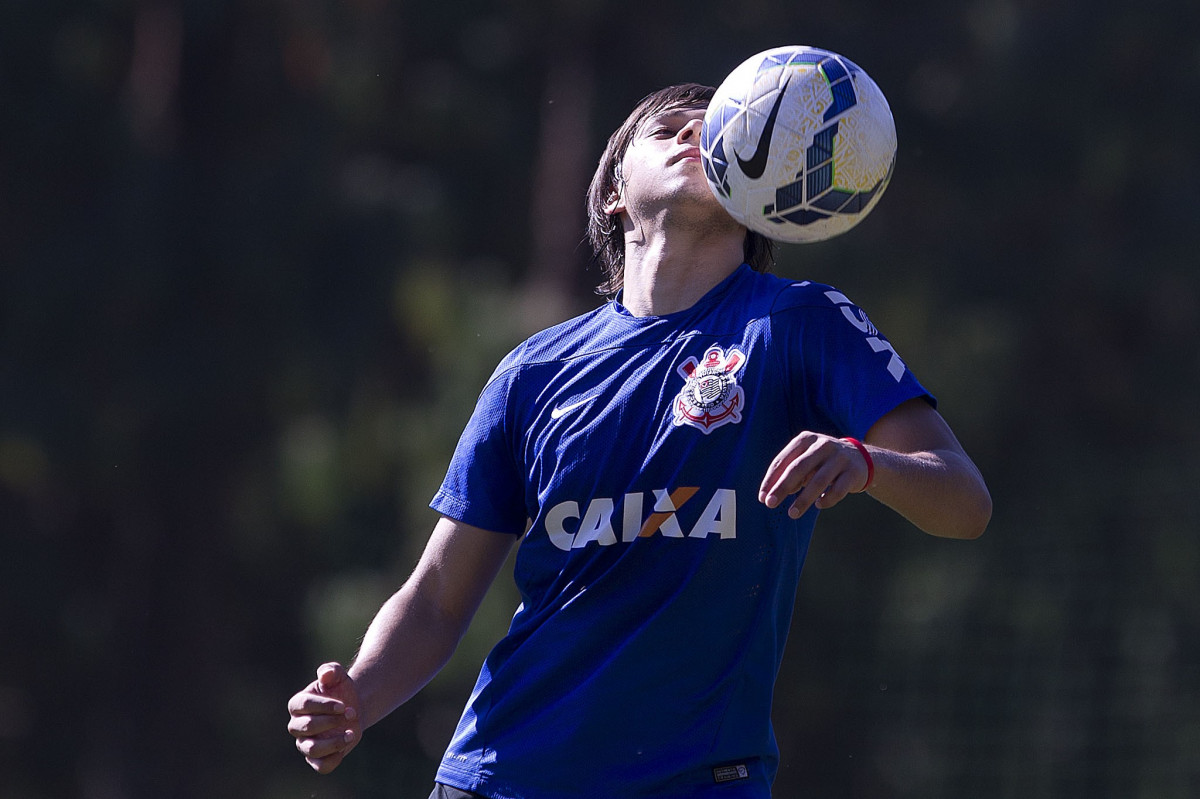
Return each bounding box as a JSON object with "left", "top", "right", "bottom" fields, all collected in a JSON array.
[{"left": 612, "top": 108, "right": 720, "bottom": 218}]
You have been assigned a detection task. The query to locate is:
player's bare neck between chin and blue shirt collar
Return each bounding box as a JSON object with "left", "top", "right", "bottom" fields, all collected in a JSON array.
[{"left": 622, "top": 228, "right": 745, "bottom": 317}]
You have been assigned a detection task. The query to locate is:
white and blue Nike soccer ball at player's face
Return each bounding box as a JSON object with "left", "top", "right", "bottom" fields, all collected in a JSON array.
[{"left": 700, "top": 46, "right": 896, "bottom": 242}]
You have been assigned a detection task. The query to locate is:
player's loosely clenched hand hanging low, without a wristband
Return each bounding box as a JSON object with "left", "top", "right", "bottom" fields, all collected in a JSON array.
[{"left": 288, "top": 663, "right": 362, "bottom": 774}]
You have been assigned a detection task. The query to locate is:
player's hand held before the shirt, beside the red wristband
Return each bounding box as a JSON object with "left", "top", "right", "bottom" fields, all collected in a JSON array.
[{"left": 758, "top": 432, "right": 868, "bottom": 518}]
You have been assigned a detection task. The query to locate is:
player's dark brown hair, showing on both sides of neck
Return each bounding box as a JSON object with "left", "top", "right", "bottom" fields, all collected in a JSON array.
[{"left": 587, "top": 83, "right": 775, "bottom": 294}]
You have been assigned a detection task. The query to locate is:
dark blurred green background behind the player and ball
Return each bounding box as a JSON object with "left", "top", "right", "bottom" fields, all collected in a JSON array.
[{"left": 0, "top": 0, "right": 1200, "bottom": 799}]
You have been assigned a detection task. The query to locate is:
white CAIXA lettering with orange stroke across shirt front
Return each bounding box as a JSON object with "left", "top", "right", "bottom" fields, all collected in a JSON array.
[{"left": 545, "top": 486, "right": 738, "bottom": 552}]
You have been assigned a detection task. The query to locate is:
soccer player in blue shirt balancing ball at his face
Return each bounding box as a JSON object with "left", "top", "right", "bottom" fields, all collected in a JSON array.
[{"left": 288, "top": 84, "right": 991, "bottom": 799}]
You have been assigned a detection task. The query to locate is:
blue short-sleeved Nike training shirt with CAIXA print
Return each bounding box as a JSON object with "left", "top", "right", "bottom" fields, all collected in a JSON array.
[{"left": 432, "top": 264, "right": 934, "bottom": 799}]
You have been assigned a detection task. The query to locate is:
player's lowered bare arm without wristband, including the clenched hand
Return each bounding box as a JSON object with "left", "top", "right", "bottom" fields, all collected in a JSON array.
[{"left": 288, "top": 517, "right": 516, "bottom": 774}]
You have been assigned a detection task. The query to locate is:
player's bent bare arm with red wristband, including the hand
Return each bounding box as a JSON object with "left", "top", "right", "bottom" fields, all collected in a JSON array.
[{"left": 758, "top": 398, "right": 991, "bottom": 539}]
